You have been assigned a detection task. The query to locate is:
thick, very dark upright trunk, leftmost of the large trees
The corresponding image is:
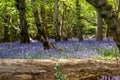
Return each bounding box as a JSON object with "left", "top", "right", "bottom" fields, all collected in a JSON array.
[{"left": 16, "top": 0, "right": 30, "bottom": 43}]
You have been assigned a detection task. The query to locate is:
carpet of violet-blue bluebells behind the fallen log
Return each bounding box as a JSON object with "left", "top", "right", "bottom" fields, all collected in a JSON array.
[{"left": 0, "top": 38, "right": 117, "bottom": 59}]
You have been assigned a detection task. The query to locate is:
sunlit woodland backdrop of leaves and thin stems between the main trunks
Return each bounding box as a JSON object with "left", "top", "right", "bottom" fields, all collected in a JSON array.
[{"left": 0, "top": 0, "right": 97, "bottom": 41}]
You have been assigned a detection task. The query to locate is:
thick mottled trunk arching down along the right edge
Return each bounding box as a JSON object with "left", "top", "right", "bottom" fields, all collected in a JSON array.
[{"left": 86, "top": 0, "right": 120, "bottom": 53}]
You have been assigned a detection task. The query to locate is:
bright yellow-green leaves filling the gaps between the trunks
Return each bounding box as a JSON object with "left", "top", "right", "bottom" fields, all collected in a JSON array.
[{"left": 0, "top": 0, "right": 102, "bottom": 37}]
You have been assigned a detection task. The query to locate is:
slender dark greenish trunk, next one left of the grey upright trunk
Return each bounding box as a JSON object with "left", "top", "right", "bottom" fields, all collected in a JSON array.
[{"left": 76, "top": 0, "right": 83, "bottom": 41}]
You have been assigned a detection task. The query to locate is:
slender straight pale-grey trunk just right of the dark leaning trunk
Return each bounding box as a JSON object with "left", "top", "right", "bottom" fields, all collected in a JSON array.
[{"left": 54, "top": 0, "right": 61, "bottom": 41}]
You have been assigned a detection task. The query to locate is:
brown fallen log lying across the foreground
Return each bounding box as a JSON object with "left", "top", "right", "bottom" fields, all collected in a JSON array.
[{"left": 0, "top": 59, "right": 120, "bottom": 80}]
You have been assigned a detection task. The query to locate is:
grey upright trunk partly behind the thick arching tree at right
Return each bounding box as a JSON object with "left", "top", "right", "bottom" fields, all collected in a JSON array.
[{"left": 95, "top": 11, "right": 103, "bottom": 41}]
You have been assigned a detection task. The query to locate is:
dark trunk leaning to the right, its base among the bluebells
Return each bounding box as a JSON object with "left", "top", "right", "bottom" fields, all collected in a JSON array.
[{"left": 31, "top": 0, "right": 55, "bottom": 49}]
